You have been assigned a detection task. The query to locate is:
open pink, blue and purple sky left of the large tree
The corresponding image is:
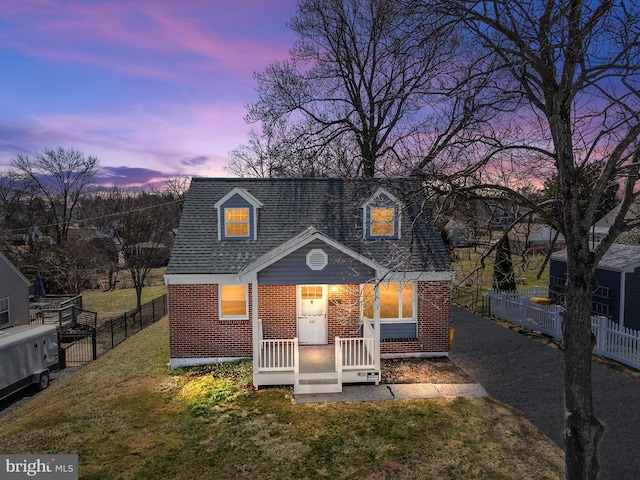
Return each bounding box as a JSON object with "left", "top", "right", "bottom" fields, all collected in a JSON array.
[{"left": 0, "top": 0, "right": 295, "bottom": 185}]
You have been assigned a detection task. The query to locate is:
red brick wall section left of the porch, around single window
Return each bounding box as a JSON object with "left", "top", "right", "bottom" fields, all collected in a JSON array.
[{"left": 168, "top": 284, "right": 253, "bottom": 358}]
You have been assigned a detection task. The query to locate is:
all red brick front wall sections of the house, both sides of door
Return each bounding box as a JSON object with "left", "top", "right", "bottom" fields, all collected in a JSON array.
[{"left": 168, "top": 282, "right": 451, "bottom": 358}]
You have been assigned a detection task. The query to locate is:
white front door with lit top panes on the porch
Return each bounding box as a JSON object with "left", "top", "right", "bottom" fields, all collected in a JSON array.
[{"left": 298, "top": 285, "right": 328, "bottom": 345}]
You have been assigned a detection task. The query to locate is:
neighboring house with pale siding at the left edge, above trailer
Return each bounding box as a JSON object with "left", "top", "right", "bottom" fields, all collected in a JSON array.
[{"left": 0, "top": 253, "right": 31, "bottom": 329}]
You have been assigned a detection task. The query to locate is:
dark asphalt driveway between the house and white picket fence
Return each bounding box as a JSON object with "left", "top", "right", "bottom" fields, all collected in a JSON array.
[{"left": 451, "top": 307, "right": 640, "bottom": 480}]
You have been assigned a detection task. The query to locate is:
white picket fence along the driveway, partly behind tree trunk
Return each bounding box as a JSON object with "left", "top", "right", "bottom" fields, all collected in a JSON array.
[{"left": 487, "top": 287, "right": 640, "bottom": 370}]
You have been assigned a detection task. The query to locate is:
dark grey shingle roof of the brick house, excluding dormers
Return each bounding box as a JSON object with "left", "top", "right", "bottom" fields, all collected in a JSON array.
[{"left": 167, "top": 178, "right": 451, "bottom": 274}]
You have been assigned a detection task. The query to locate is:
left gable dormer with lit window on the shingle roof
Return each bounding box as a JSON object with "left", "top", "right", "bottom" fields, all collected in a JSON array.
[{"left": 214, "top": 187, "right": 262, "bottom": 240}]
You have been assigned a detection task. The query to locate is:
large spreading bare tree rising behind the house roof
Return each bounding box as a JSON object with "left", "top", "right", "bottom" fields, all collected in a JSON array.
[{"left": 244, "top": 0, "right": 493, "bottom": 177}]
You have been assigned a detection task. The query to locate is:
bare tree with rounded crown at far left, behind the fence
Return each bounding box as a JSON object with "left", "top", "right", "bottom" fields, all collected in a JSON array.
[{"left": 11, "top": 147, "right": 98, "bottom": 245}]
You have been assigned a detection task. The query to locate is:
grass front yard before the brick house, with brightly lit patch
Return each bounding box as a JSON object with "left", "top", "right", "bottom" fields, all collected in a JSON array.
[{"left": 0, "top": 318, "right": 563, "bottom": 480}]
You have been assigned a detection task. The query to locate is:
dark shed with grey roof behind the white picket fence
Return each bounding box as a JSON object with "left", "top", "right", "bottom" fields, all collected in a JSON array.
[{"left": 549, "top": 243, "right": 640, "bottom": 330}]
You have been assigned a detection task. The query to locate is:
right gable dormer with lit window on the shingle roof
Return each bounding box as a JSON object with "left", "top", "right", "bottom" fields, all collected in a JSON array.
[{"left": 362, "top": 188, "right": 402, "bottom": 240}]
